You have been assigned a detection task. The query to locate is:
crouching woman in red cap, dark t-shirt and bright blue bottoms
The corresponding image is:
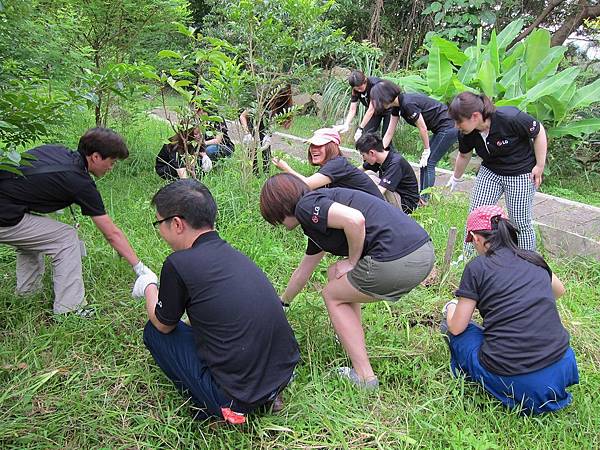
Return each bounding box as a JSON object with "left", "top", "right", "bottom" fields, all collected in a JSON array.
[{"left": 442, "top": 205, "right": 579, "bottom": 414}]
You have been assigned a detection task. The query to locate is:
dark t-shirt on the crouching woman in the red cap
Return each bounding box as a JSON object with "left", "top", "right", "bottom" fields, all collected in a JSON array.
[{"left": 455, "top": 248, "right": 569, "bottom": 375}]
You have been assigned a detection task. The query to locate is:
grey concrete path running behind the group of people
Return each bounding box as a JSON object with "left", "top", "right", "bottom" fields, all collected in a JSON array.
[{"left": 152, "top": 108, "right": 600, "bottom": 260}]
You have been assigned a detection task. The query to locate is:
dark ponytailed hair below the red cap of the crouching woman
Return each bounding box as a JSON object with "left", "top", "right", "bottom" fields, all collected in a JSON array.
[{"left": 472, "top": 216, "right": 552, "bottom": 277}]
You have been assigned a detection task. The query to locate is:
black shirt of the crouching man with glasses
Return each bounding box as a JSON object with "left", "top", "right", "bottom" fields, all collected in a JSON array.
[{"left": 155, "top": 231, "right": 299, "bottom": 405}]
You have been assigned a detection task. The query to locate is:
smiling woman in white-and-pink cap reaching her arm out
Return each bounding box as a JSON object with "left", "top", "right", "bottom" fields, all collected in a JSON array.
[{"left": 273, "top": 128, "right": 383, "bottom": 199}]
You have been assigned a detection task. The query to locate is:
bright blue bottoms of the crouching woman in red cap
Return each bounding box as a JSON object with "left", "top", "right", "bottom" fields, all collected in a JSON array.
[{"left": 448, "top": 323, "right": 579, "bottom": 414}]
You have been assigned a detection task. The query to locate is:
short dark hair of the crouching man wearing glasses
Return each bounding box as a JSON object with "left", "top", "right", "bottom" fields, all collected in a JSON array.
[{"left": 152, "top": 178, "right": 217, "bottom": 230}]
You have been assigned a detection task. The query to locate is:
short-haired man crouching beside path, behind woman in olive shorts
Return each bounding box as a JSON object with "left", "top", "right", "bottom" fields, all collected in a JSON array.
[{"left": 356, "top": 133, "right": 419, "bottom": 214}]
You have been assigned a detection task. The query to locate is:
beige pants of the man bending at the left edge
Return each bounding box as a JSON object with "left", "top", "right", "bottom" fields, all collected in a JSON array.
[{"left": 0, "top": 214, "right": 86, "bottom": 314}]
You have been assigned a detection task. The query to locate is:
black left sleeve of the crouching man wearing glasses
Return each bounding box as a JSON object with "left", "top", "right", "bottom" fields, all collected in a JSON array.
[{"left": 154, "top": 258, "right": 189, "bottom": 325}]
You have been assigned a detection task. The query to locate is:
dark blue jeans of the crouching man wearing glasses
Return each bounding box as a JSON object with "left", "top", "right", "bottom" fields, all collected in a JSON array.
[{"left": 144, "top": 322, "right": 243, "bottom": 419}]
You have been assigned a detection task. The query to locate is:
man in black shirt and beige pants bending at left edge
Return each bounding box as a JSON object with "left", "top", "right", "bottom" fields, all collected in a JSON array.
[{"left": 0, "top": 128, "right": 152, "bottom": 314}]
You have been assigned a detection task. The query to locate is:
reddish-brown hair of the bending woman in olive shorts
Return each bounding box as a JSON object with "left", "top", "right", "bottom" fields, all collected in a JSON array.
[{"left": 260, "top": 173, "right": 310, "bottom": 225}]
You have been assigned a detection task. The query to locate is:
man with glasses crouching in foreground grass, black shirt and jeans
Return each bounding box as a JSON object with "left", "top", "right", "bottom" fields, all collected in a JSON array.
[{"left": 133, "top": 179, "right": 299, "bottom": 423}]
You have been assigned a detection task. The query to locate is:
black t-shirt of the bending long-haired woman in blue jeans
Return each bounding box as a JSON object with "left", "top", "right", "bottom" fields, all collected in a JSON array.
[{"left": 392, "top": 94, "right": 454, "bottom": 133}]
